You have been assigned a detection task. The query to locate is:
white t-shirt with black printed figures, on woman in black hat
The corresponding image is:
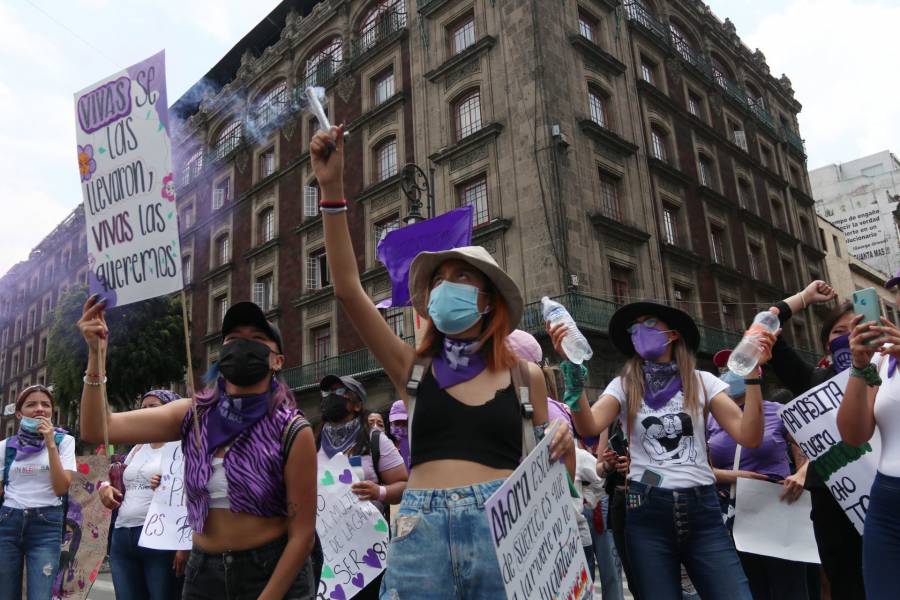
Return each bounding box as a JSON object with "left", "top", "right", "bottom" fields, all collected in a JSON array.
[{"left": 603, "top": 371, "right": 728, "bottom": 489}]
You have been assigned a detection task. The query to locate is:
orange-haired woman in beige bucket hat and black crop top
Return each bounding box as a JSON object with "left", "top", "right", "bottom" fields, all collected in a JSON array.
[{"left": 310, "top": 127, "right": 574, "bottom": 600}]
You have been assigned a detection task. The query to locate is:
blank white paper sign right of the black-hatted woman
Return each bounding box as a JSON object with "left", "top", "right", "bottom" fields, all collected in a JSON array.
[{"left": 733, "top": 477, "right": 820, "bottom": 564}]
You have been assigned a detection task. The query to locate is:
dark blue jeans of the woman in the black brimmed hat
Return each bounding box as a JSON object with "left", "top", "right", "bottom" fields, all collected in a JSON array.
[{"left": 625, "top": 481, "right": 752, "bottom": 600}]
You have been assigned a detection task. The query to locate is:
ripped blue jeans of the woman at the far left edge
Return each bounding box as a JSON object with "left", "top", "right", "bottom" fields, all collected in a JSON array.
[{"left": 0, "top": 506, "right": 63, "bottom": 600}]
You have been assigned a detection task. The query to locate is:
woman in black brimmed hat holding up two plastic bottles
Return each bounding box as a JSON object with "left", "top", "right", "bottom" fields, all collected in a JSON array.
[{"left": 564, "top": 302, "right": 775, "bottom": 600}]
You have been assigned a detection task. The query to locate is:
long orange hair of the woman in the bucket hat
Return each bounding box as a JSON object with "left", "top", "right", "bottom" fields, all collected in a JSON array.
[{"left": 416, "top": 282, "right": 516, "bottom": 371}]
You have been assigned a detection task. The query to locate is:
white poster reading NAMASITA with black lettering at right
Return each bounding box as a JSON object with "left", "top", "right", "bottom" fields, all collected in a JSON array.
[{"left": 781, "top": 369, "right": 881, "bottom": 535}]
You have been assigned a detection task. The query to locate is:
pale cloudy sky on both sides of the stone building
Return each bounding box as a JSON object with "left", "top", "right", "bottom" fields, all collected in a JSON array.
[{"left": 0, "top": 0, "right": 900, "bottom": 274}]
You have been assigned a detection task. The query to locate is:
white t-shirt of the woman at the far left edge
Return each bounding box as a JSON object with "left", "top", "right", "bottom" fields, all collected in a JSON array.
[{"left": 0, "top": 435, "right": 76, "bottom": 510}]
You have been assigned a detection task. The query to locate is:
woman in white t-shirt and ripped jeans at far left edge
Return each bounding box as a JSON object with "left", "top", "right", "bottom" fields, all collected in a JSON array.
[{"left": 0, "top": 385, "right": 75, "bottom": 600}]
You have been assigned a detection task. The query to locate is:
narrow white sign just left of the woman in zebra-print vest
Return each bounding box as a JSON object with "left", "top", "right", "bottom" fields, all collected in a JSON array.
[{"left": 138, "top": 442, "right": 193, "bottom": 550}]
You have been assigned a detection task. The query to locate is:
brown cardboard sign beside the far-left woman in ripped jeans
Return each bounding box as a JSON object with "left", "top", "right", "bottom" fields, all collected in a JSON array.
[{"left": 53, "top": 456, "right": 112, "bottom": 600}]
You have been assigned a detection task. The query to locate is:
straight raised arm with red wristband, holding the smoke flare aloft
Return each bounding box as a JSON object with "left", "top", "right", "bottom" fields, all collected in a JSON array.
[{"left": 310, "top": 126, "right": 415, "bottom": 391}]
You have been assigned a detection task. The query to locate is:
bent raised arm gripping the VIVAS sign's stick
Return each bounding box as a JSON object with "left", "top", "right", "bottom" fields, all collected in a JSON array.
[{"left": 78, "top": 295, "right": 191, "bottom": 444}]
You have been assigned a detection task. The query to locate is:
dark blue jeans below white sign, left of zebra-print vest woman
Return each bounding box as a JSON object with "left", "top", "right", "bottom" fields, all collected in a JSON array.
[{"left": 109, "top": 527, "right": 178, "bottom": 600}]
